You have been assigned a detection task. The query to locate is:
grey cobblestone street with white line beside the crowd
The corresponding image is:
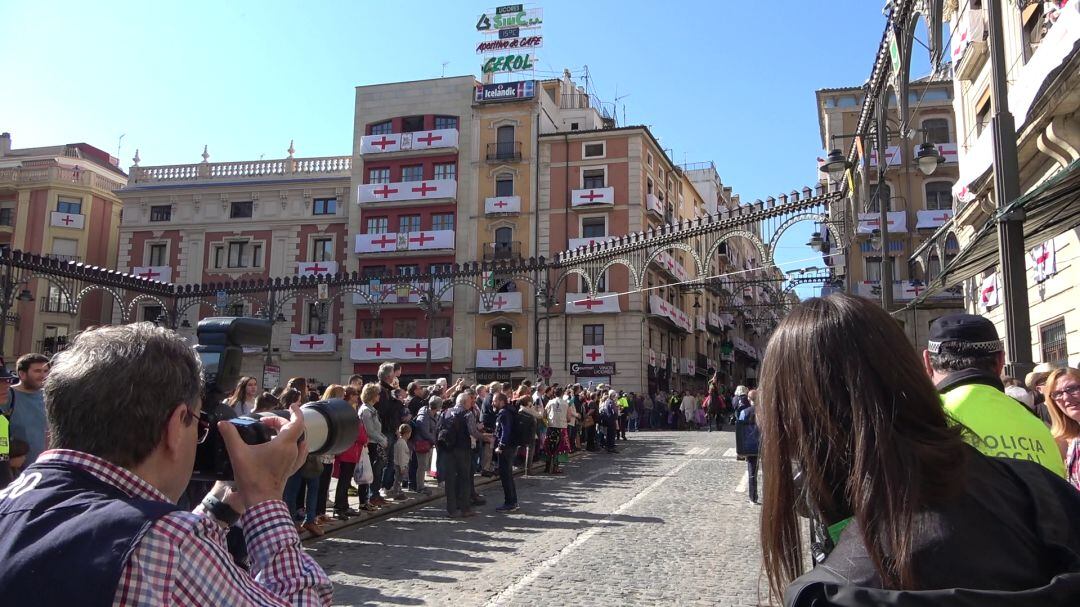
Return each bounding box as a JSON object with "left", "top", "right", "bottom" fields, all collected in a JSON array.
[{"left": 308, "top": 432, "right": 764, "bottom": 606}]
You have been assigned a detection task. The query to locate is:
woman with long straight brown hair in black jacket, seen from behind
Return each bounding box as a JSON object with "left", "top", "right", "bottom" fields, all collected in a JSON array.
[{"left": 757, "top": 295, "right": 1080, "bottom": 605}]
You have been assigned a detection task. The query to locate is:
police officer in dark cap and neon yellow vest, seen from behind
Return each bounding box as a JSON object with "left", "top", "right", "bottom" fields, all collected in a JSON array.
[{"left": 922, "top": 312, "right": 1065, "bottom": 477}]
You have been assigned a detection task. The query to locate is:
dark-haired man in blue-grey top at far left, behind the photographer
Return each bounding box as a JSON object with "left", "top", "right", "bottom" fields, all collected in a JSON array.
[{"left": 6, "top": 354, "right": 49, "bottom": 464}]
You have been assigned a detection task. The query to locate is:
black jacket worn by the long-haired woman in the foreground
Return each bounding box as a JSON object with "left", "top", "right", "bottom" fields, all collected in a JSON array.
[{"left": 784, "top": 447, "right": 1080, "bottom": 607}]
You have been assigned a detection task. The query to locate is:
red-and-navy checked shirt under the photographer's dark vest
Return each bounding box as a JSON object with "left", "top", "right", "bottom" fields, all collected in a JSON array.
[{"left": 38, "top": 449, "right": 333, "bottom": 606}]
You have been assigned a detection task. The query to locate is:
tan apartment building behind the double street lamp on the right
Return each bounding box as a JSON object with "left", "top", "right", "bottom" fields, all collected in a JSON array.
[{"left": 816, "top": 78, "right": 963, "bottom": 348}]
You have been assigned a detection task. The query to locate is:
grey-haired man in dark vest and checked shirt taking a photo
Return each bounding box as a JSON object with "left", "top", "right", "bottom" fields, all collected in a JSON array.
[{"left": 0, "top": 323, "right": 333, "bottom": 605}]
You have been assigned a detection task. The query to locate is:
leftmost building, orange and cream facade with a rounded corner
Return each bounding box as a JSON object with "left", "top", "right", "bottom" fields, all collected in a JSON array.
[{"left": 0, "top": 133, "right": 127, "bottom": 358}]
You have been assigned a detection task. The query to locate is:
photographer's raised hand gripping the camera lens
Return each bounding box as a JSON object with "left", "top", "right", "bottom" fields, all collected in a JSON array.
[{"left": 217, "top": 405, "right": 308, "bottom": 509}]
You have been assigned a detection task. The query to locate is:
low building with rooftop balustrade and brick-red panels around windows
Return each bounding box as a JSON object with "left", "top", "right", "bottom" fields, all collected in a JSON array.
[{"left": 116, "top": 144, "right": 352, "bottom": 382}]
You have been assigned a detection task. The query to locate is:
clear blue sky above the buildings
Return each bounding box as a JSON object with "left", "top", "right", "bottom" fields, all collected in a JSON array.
[{"left": 0, "top": 0, "right": 921, "bottom": 280}]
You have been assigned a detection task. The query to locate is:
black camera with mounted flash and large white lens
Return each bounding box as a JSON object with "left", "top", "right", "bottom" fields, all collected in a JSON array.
[{"left": 191, "top": 318, "right": 360, "bottom": 481}]
